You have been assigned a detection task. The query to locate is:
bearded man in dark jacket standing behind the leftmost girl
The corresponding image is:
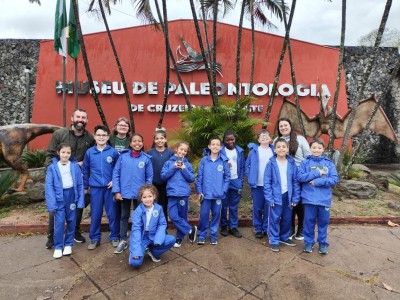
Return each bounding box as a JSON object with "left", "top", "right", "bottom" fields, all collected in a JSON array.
[{"left": 46, "top": 108, "right": 94, "bottom": 249}]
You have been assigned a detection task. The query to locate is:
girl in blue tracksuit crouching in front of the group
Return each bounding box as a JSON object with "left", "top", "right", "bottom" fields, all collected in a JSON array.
[{"left": 129, "top": 184, "right": 175, "bottom": 268}]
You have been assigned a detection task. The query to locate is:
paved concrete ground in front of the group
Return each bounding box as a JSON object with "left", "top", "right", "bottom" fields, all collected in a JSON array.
[{"left": 0, "top": 225, "right": 400, "bottom": 300}]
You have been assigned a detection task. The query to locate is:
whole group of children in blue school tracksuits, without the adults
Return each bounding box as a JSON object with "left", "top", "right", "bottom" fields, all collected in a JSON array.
[{"left": 46, "top": 125, "right": 338, "bottom": 267}]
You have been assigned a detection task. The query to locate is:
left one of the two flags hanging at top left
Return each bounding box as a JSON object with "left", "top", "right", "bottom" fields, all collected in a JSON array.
[{"left": 54, "top": 0, "right": 68, "bottom": 57}]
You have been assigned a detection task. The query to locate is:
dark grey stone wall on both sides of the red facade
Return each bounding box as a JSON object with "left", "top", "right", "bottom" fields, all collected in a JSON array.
[{"left": 0, "top": 40, "right": 400, "bottom": 163}]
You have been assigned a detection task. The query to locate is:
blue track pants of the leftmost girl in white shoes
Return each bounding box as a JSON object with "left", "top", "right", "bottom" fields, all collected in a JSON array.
[{"left": 54, "top": 187, "right": 76, "bottom": 250}]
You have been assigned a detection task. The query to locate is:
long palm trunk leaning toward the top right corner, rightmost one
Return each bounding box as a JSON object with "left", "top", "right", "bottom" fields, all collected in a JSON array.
[{"left": 338, "top": 0, "right": 392, "bottom": 176}]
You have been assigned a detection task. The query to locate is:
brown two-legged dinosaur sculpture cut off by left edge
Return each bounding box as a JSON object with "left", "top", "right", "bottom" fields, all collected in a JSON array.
[{"left": 0, "top": 123, "right": 61, "bottom": 192}]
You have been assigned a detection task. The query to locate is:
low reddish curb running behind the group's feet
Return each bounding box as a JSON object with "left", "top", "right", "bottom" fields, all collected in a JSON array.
[{"left": 0, "top": 216, "right": 400, "bottom": 235}]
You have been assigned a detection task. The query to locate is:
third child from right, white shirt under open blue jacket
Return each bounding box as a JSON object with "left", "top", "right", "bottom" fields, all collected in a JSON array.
[{"left": 246, "top": 129, "right": 274, "bottom": 239}]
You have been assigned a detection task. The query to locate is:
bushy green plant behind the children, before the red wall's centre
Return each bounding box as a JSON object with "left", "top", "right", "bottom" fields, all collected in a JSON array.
[{"left": 171, "top": 97, "right": 262, "bottom": 165}]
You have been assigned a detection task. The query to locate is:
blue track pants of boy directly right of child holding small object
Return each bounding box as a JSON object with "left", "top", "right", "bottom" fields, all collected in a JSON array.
[{"left": 198, "top": 199, "right": 222, "bottom": 240}]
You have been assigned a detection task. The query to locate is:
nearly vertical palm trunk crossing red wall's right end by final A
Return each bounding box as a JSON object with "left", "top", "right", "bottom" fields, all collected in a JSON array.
[{"left": 328, "top": 0, "right": 346, "bottom": 157}]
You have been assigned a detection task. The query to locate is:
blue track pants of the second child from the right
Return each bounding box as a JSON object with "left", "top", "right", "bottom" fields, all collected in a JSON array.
[{"left": 266, "top": 193, "right": 292, "bottom": 245}]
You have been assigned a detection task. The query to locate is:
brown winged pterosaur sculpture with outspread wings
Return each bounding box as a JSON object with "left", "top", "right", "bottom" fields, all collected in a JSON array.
[{"left": 276, "top": 89, "right": 399, "bottom": 143}]
